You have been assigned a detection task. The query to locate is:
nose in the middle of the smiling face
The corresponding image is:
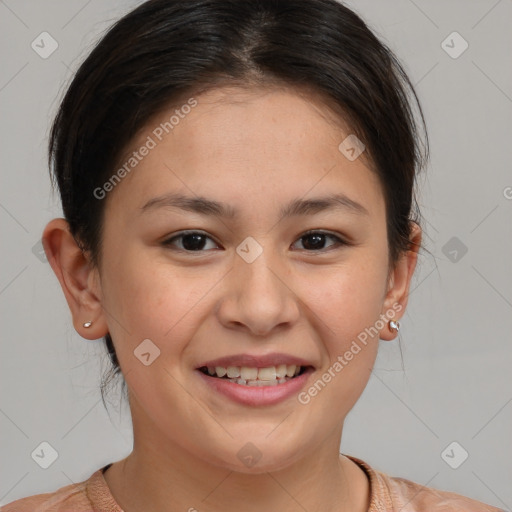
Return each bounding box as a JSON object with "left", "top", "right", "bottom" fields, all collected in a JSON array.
[{"left": 217, "top": 248, "right": 300, "bottom": 336}]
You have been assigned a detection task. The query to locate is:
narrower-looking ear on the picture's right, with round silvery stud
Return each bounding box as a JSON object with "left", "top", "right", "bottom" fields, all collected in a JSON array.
[{"left": 380, "top": 221, "right": 421, "bottom": 341}]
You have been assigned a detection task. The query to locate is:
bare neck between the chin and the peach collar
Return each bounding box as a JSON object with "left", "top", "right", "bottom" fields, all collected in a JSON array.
[{"left": 104, "top": 436, "right": 370, "bottom": 512}]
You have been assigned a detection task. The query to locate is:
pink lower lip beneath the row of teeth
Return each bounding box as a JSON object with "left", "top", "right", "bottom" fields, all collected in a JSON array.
[{"left": 196, "top": 367, "right": 314, "bottom": 406}]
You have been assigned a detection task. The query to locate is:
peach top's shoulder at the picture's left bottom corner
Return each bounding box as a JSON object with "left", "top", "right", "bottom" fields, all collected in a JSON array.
[{"left": 0, "top": 475, "right": 93, "bottom": 512}]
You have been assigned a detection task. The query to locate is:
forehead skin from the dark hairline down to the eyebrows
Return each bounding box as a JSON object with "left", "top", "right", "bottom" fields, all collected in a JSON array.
[{"left": 105, "top": 87, "right": 380, "bottom": 220}]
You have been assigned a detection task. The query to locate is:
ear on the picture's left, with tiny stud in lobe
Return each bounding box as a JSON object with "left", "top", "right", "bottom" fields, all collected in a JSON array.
[{"left": 42, "top": 219, "right": 108, "bottom": 340}]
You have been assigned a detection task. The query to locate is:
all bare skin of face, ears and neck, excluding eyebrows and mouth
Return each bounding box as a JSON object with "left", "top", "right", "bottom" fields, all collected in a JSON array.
[{"left": 43, "top": 88, "right": 421, "bottom": 512}]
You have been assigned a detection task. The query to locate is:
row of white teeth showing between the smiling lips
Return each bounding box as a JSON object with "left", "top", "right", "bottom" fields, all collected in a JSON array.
[{"left": 198, "top": 364, "right": 313, "bottom": 386}]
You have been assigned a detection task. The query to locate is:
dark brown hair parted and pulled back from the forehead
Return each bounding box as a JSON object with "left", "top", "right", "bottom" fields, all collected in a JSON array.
[{"left": 49, "top": 0, "right": 428, "bottom": 410}]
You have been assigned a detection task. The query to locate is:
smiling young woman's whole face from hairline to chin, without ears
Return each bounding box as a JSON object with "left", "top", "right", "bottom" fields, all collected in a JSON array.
[{"left": 46, "top": 84, "right": 418, "bottom": 472}]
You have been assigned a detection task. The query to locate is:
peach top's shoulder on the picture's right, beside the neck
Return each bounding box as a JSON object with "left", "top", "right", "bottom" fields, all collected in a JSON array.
[{"left": 347, "top": 455, "right": 504, "bottom": 512}]
